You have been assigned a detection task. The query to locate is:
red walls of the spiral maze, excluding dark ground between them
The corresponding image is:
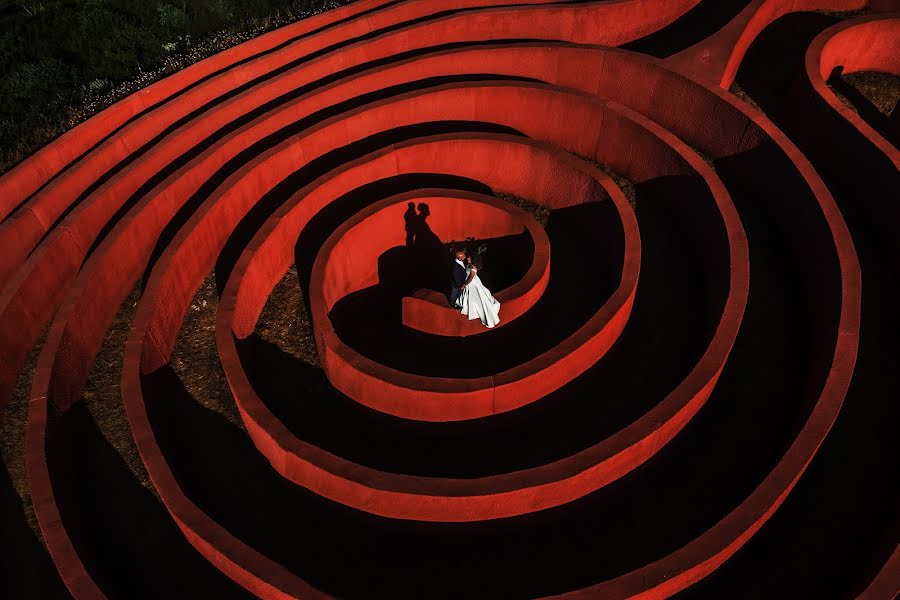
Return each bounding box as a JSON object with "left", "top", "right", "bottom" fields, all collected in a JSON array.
[{"left": 0, "top": 0, "right": 900, "bottom": 597}]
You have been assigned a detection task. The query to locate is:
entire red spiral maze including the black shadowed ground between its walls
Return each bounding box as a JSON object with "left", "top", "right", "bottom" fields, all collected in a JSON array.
[{"left": 0, "top": 0, "right": 900, "bottom": 598}]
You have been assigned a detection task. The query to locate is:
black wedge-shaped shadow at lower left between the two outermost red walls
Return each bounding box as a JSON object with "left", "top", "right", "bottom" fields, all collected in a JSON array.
[{"left": 48, "top": 402, "right": 249, "bottom": 599}]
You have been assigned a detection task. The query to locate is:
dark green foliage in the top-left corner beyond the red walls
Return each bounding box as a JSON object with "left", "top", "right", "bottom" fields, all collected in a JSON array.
[{"left": 0, "top": 0, "right": 346, "bottom": 170}]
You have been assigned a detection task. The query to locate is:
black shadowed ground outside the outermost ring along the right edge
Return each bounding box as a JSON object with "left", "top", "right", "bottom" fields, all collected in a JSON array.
[{"left": 683, "top": 14, "right": 900, "bottom": 599}]
